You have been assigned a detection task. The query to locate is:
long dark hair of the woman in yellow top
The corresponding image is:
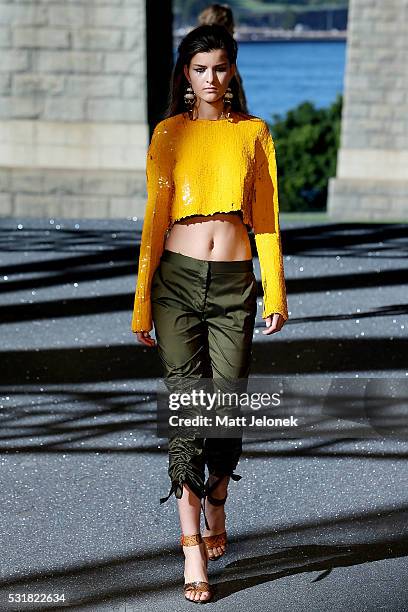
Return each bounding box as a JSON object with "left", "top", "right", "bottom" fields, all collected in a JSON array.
[{"left": 164, "top": 24, "right": 248, "bottom": 119}]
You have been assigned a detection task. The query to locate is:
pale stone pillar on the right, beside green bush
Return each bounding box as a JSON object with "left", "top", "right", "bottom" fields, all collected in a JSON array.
[{"left": 328, "top": 0, "right": 408, "bottom": 221}]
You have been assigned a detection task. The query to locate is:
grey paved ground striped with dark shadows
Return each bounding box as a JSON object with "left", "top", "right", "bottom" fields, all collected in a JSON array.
[{"left": 0, "top": 218, "right": 408, "bottom": 612}]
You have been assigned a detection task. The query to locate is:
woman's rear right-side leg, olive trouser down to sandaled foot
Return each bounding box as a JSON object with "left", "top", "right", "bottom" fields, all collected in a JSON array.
[{"left": 203, "top": 262, "right": 257, "bottom": 559}]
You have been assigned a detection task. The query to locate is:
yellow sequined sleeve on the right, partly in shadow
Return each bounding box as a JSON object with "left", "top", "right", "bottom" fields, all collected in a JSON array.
[{"left": 252, "top": 121, "right": 289, "bottom": 320}]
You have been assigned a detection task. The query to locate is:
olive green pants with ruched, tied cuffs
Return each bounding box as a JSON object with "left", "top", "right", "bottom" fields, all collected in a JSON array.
[{"left": 151, "top": 249, "right": 257, "bottom": 520}]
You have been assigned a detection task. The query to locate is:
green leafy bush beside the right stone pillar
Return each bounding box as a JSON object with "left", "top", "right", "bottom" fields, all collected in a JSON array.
[{"left": 270, "top": 94, "right": 343, "bottom": 211}]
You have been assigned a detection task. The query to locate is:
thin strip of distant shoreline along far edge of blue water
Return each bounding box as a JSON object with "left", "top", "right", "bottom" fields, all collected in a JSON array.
[{"left": 174, "top": 25, "right": 347, "bottom": 45}]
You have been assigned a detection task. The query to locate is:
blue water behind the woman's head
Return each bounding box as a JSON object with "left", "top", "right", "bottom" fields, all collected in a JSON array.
[{"left": 174, "top": 41, "right": 346, "bottom": 121}]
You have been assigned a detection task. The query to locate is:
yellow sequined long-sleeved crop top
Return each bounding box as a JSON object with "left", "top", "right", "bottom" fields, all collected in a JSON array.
[{"left": 131, "top": 112, "right": 288, "bottom": 332}]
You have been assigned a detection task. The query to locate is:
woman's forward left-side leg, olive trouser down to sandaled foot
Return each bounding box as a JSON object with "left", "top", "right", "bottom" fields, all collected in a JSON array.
[{"left": 152, "top": 256, "right": 211, "bottom": 601}]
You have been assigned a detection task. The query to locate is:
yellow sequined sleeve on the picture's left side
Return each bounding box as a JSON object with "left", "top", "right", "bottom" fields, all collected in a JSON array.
[{"left": 132, "top": 121, "right": 173, "bottom": 332}]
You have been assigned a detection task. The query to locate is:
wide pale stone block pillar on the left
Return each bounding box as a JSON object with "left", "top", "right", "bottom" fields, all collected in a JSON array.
[{"left": 0, "top": 0, "right": 171, "bottom": 218}]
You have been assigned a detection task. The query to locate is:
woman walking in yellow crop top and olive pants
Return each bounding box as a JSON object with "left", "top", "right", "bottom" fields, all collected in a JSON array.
[{"left": 132, "top": 25, "right": 288, "bottom": 603}]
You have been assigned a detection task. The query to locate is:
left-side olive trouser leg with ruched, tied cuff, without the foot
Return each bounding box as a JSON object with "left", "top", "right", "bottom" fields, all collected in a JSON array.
[{"left": 151, "top": 261, "right": 210, "bottom": 510}]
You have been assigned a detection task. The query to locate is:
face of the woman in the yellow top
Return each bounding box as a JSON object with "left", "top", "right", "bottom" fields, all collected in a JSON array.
[{"left": 184, "top": 49, "right": 235, "bottom": 102}]
